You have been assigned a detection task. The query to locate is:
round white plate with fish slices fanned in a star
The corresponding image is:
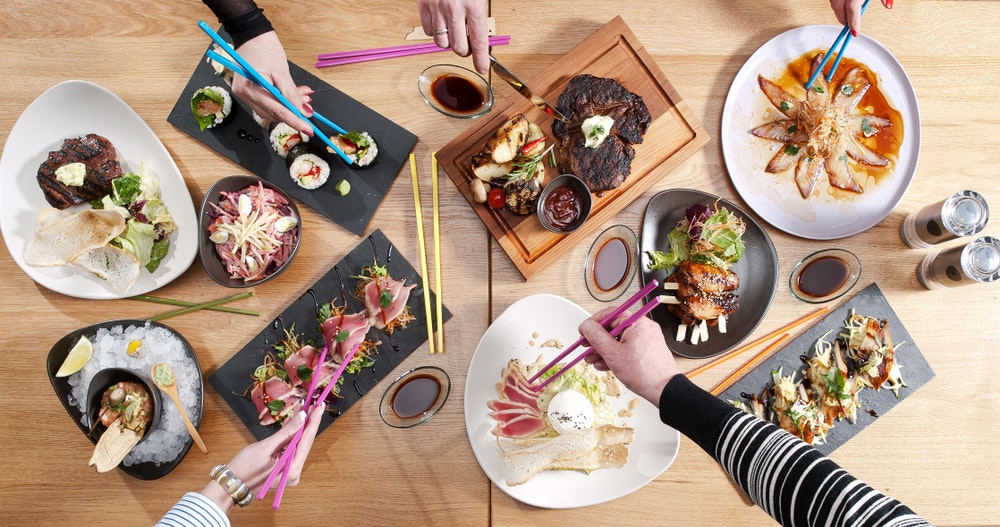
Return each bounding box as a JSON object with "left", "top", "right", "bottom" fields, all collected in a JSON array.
[{"left": 721, "top": 26, "right": 920, "bottom": 240}]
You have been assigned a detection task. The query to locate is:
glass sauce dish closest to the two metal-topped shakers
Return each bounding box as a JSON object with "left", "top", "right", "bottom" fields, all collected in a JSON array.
[{"left": 788, "top": 249, "right": 861, "bottom": 304}]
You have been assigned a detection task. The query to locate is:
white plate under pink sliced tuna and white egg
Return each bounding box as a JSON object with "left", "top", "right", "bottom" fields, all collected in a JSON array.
[{"left": 465, "top": 294, "right": 680, "bottom": 509}]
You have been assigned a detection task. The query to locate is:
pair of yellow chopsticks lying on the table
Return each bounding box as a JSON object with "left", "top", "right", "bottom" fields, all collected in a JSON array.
[{"left": 410, "top": 152, "right": 444, "bottom": 355}]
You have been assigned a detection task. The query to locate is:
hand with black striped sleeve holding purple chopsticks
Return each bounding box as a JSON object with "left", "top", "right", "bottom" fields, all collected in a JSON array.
[{"left": 579, "top": 308, "right": 680, "bottom": 406}]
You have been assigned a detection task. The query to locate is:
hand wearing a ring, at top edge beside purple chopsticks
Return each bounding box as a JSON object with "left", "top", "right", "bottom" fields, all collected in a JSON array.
[{"left": 417, "top": 0, "right": 490, "bottom": 74}]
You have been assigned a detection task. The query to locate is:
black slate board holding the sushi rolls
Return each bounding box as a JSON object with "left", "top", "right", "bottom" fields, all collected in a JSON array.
[{"left": 167, "top": 32, "right": 417, "bottom": 236}]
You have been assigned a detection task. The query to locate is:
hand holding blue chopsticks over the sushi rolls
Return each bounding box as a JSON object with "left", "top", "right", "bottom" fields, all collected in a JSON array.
[{"left": 233, "top": 31, "right": 313, "bottom": 136}]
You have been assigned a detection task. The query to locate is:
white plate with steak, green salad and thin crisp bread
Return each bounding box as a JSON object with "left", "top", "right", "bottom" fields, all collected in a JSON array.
[{"left": 0, "top": 80, "right": 198, "bottom": 299}]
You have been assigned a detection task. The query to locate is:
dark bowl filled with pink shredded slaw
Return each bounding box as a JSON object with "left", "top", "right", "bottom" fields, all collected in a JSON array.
[{"left": 198, "top": 176, "right": 302, "bottom": 287}]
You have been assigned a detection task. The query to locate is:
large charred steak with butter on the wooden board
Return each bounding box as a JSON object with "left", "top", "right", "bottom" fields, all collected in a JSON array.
[{"left": 552, "top": 74, "right": 652, "bottom": 194}]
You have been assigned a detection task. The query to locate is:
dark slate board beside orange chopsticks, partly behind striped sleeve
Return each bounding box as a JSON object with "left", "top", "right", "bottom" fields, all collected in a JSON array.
[{"left": 719, "top": 283, "right": 934, "bottom": 455}]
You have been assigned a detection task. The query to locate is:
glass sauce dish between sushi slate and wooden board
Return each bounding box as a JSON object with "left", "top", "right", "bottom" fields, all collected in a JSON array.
[{"left": 417, "top": 64, "right": 493, "bottom": 119}]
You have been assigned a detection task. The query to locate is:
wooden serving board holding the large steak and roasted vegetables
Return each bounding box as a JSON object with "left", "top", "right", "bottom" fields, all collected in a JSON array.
[{"left": 437, "top": 17, "right": 709, "bottom": 279}]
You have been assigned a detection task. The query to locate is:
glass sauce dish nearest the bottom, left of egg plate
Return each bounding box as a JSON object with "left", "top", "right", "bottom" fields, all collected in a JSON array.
[{"left": 378, "top": 366, "right": 451, "bottom": 428}]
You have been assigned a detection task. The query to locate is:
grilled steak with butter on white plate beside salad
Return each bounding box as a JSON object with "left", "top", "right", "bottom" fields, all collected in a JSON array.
[{"left": 36, "top": 134, "right": 122, "bottom": 209}]
